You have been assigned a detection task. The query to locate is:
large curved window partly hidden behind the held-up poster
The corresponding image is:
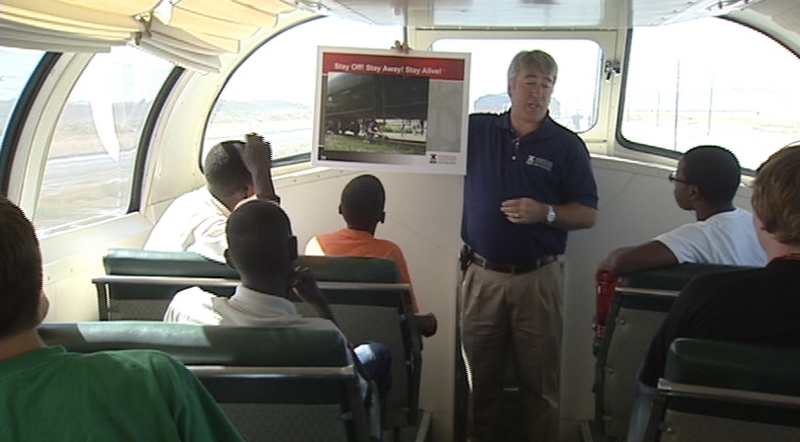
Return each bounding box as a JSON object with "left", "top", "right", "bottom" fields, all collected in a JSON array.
[{"left": 203, "top": 17, "right": 403, "bottom": 164}]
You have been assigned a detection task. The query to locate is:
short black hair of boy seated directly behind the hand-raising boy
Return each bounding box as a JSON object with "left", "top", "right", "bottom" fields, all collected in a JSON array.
[{"left": 225, "top": 200, "right": 297, "bottom": 276}]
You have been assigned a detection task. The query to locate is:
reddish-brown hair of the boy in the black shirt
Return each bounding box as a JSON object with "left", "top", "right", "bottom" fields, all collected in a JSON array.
[{"left": 751, "top": 143, "right": 800, "bottom": 244}]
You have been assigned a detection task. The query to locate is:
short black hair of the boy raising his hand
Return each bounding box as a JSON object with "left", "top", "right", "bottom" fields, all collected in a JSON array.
[{"left": 203, "top": 140, "right": 253, "bottom": 198}]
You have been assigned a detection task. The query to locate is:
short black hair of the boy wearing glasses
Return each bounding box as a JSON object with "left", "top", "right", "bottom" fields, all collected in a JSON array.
[{"left": 682, "top": 145, "right": 742, "bottom": 204}]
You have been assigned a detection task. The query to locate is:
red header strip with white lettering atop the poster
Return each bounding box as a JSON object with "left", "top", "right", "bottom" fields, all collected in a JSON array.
[{"left": 322, "top": 52, "right": 464, "bottom": 81}]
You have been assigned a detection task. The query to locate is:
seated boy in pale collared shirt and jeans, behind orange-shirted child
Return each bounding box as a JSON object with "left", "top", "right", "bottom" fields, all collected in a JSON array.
[{"left": 164, "top": 200, "right": 392, "bottom": 422}]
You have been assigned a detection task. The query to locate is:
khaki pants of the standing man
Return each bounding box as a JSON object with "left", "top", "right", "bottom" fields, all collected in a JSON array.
[{"left": 461, "top": 260, "right": 564, "bottom": 442}]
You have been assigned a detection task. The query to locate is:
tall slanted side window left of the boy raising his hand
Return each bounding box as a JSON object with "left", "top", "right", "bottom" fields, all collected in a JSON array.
[{"left": 34, "top": 47, "right": 173, "bottom": 236}]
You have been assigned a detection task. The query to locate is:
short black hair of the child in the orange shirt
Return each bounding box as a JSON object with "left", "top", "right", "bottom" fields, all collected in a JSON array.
[{"left": 341, "top": 175, "right": 386, "bottom": 228}]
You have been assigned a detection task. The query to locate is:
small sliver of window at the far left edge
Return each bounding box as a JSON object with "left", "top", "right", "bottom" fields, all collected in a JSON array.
[{"left": 0, "top": 47, "right": 44, "bottom": 148}]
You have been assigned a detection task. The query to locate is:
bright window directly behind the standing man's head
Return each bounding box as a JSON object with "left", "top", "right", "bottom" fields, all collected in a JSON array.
[{"left": 432, "top": 38, "right": 602, "bottom": 132}]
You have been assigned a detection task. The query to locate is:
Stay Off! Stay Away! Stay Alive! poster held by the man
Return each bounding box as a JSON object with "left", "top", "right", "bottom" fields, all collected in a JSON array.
[{"left": 311, "top": 47, "right": 469, "bottom": 175}]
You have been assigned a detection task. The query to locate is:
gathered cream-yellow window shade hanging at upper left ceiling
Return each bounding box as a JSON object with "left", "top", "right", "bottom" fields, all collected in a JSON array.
[{"left": 0, "top": 0, "right": 294, "bottom": 72}]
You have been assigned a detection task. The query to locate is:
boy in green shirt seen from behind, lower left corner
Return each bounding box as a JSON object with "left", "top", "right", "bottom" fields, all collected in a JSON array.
[{"left": 0, "top": 197, "right": 243, "bottom": 442}]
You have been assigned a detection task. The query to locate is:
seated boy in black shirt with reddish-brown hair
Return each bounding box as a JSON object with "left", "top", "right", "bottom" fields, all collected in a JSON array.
[{"left": 628, "top": 145, "right": 800, "bottom": 442}]
